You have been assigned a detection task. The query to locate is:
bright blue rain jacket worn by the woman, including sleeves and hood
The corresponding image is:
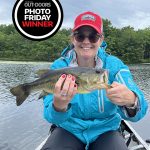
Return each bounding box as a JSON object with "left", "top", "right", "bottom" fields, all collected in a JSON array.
[{"left": 44, "top": 42, "right": 148, "bottom": 147}]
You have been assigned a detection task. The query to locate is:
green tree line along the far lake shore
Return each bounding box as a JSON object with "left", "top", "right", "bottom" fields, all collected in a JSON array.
[{"left": 0, "top": 19, "right": 150, "bottom": 63}]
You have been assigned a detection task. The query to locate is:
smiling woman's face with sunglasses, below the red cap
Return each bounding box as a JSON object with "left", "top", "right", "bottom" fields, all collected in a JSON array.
[{"left": 72, "top": 26, "right": 103, "bottom": 59}]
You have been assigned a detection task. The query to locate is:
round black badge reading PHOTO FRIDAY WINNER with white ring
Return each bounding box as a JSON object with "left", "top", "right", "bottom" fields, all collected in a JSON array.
[{"left": 12, "top": 0, "right": 63, "bottom": 40}]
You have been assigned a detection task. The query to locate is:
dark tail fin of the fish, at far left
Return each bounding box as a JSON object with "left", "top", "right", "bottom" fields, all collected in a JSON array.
[{"left": 10, "top": 85, "right": 30, "bottom": 106}]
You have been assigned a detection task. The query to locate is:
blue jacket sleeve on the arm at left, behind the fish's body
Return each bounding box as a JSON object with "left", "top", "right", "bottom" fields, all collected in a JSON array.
[{"left": 43, "top": 60, "right": 72, "bottom": 125}]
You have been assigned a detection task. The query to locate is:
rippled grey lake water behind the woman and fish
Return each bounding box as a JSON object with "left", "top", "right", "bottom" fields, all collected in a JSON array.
[{"left": 0, "top": 62, "right": 150, "bottom": 150}]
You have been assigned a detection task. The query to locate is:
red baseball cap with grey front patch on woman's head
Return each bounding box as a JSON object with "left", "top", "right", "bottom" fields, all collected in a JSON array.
[{"left": 72, "top": 11, "right": 103, "bottom": 34}]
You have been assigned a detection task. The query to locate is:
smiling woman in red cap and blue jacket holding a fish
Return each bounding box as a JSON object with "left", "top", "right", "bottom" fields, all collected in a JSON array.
[{"left": 42, "top": 12, "right": 147, "bottom": 150}]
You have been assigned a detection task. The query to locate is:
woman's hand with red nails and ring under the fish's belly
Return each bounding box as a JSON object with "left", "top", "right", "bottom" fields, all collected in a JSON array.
[{"left": 53, "top": 74, "right": 77, "bottom": 111}]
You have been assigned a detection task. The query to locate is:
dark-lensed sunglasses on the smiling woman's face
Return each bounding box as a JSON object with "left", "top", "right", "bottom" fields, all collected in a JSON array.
[{"left": 73, "top": 32, "right": 102, "bottom": 43}]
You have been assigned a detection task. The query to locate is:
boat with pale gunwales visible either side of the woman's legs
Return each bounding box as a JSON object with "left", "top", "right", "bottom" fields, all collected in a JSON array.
[{"left": 35, "top": 120, "right": 150, "bottom": 150}]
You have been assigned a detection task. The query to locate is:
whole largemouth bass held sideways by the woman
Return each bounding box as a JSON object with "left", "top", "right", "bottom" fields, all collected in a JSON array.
[{"left": 10, "top": 67, "right": 110, "bottom": 106}]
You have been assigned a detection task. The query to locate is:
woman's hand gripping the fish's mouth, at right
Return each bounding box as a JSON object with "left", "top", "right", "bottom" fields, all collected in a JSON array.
[{"left": 106, "top": 82, "right": 136, "bottom": 107}]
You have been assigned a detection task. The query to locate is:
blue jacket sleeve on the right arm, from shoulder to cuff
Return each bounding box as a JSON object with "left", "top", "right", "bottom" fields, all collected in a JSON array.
[{"left": 106, "top": 56, "right": 148, "bottom": 122}]
